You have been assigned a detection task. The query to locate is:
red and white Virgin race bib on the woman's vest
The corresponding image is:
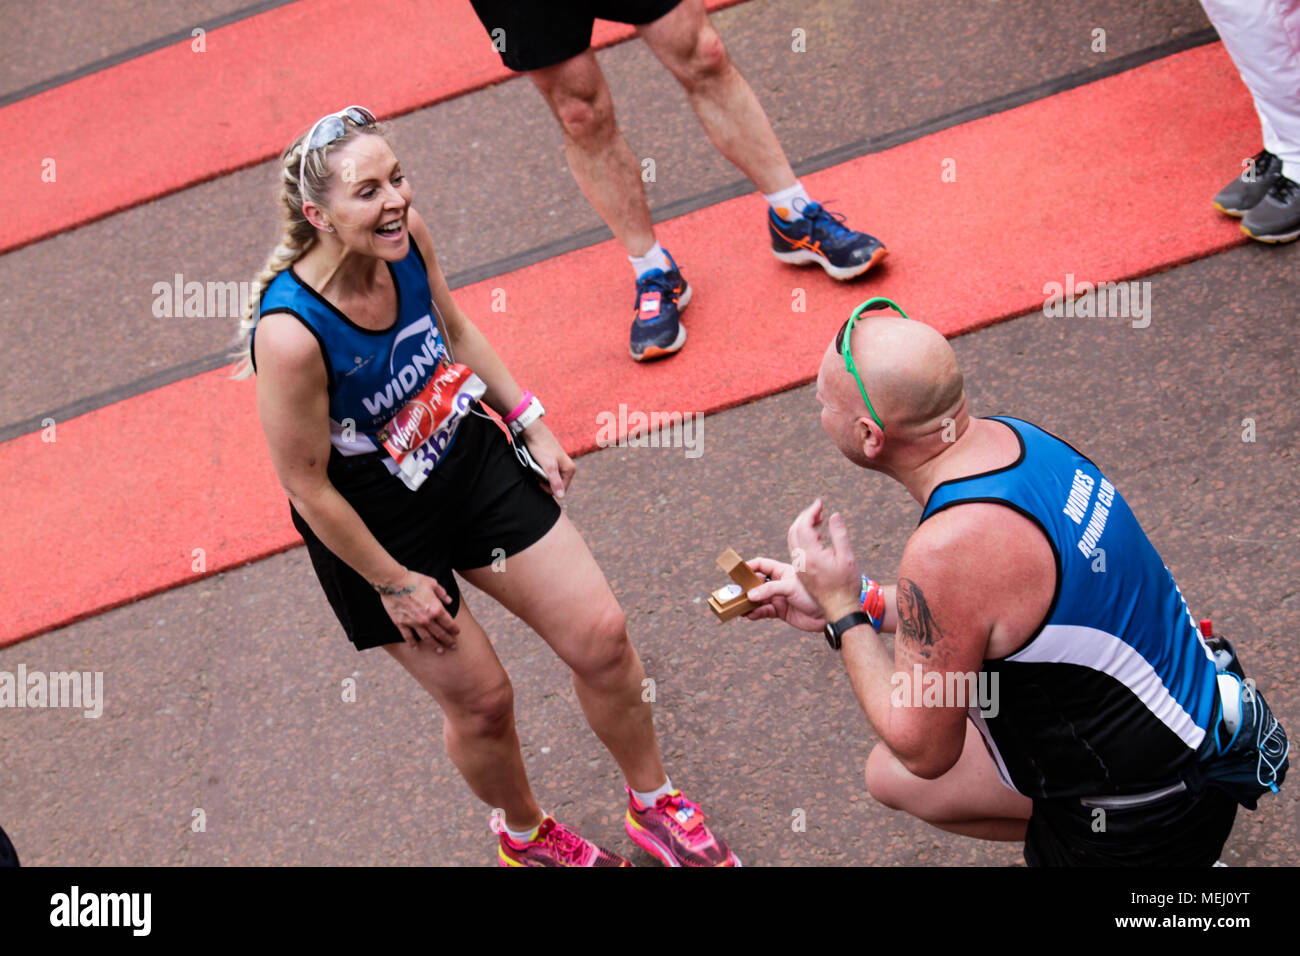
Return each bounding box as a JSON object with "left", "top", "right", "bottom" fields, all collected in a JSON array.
[{"left": 377, "top": 362, "right": 488, "bottom": 492}]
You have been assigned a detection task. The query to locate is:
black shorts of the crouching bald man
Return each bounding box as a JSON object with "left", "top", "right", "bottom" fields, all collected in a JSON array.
[{"left": 1024, "top": 787, "right": 1238, "bottom": 866}]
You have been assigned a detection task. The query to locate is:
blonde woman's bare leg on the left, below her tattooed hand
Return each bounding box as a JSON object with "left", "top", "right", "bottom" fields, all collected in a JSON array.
[{"left": 384, "top": 598, "right": 542, "bottom": 830}]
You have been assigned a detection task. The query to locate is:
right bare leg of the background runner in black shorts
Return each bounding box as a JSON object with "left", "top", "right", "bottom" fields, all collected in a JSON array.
[{"left": 638, "top": 0, "right": 794, "bottom": 193}]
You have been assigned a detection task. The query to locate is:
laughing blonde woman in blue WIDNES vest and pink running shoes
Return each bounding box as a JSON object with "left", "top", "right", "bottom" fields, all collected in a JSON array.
[{"left": 238, "top": 107, "right": 740, "bottom": 866}]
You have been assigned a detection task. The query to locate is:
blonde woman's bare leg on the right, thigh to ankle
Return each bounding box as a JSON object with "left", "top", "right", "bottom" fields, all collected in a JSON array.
[{"left": 464, "top": 515, "right": 667, "bottom": 791}]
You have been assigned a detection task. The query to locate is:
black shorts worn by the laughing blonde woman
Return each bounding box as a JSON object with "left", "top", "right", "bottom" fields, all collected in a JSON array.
[{"left": 289, "top": 415, "right": 560, "bottom": 650}]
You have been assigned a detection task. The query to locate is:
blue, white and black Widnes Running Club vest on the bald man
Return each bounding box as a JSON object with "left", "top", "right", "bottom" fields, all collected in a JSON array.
[{"left": 920, "top": 418, "right": 1218, "bottom": 799}]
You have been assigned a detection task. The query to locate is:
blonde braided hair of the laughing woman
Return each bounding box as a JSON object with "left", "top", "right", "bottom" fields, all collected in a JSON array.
[{"left": 231, "top": 115, "right": 391, "bottom": 378}]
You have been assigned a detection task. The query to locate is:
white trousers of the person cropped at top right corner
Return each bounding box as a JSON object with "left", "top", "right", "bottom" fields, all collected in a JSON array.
[{"left": 1201, "top": 0, "right": 1300, "bottom": 182}]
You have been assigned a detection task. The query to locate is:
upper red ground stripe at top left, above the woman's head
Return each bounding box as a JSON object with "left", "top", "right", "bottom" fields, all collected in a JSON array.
[{"left": 0, "top": 0, "right": 740, "bottom": 252}]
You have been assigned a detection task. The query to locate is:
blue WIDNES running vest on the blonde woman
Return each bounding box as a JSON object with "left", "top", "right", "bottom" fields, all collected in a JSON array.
[{"left": 250, "top": 239, "right": 455, "bottom": 473}]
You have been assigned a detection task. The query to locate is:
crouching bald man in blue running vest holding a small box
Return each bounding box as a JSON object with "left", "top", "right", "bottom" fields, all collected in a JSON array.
[{"left": 748, "top": 303, "right": 1284, "bottom": 866}]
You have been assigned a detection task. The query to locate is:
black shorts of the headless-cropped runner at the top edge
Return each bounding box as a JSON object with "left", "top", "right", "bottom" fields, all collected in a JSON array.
[{"left": 469, "top": 0, "right": 681, "bottom": 73}]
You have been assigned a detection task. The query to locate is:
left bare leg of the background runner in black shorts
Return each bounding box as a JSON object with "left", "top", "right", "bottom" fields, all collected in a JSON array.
[{"left": 528, "top": 49, "right": 654, "bottom": 256}]
